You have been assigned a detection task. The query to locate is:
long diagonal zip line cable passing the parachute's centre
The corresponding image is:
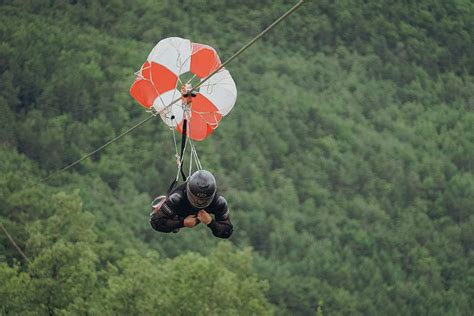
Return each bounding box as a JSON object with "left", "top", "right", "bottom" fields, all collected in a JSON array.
[{"left": 41, "top": 0, "right": 304, "bottom": 182}]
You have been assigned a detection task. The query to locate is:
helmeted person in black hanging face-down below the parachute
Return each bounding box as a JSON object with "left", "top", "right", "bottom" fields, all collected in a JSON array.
[{"left": 150, "top": 170, "right": 233, "bottom": 238}]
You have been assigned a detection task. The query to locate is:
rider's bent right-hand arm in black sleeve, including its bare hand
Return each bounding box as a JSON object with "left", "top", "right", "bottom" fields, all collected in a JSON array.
[{"left": 198, "top": 197, "right": 234, "bottom": 238}]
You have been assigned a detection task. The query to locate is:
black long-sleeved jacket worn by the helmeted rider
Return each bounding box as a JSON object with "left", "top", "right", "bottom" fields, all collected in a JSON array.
[{"left": 150, "top": 183, "right": 233, "bottom": 238}]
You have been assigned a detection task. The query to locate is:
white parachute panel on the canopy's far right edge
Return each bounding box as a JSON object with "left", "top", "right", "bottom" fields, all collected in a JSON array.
[{"left": 199, "top": 70, "right": 237, "bottom": 115}]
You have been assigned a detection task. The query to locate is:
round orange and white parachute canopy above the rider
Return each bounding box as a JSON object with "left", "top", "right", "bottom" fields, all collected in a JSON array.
[{"left": 130, "top": 37, "right": 237, "bottom": 140}]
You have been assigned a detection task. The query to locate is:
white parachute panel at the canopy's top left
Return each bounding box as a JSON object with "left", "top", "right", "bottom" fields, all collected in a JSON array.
[{"left": 148, "top": 37, "right": 191, "bottom": 76}]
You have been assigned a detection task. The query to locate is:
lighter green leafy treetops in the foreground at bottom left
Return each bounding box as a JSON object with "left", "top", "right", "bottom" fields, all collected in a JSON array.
[{"left": 0, "top": 183, "right": 272, "bottom": 315}]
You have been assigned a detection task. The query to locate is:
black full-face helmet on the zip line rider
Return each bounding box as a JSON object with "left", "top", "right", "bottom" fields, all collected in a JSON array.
[{"left": 186, "top": 170, "right": 216, "bottom": 208}]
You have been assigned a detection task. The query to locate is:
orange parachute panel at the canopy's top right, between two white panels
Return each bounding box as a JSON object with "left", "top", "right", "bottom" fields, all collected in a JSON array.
[{"left": 190, "top": 43, "right": 221, "bottom": 78}]
